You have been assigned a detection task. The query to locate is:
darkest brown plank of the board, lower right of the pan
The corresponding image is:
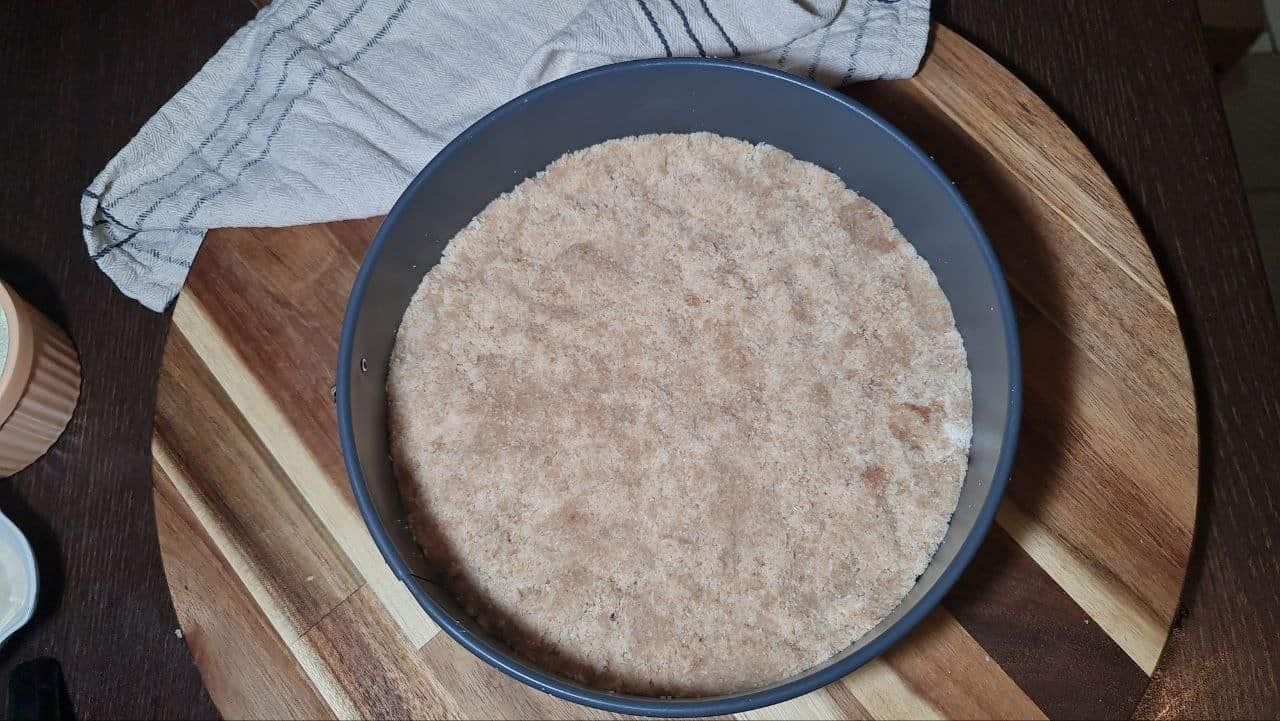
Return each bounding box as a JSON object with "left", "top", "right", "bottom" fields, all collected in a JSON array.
[{"left": 943, "top": 528, "right": 1148, "bottom": 718}]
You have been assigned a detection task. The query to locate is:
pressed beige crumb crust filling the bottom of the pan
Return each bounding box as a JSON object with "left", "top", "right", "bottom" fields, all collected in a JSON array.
[{"left": 388, "top": 133, "right": 972, "bottom": 695}]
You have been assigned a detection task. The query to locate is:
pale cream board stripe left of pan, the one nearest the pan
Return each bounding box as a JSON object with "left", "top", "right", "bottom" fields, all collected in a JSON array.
[{"left": 173, "top": 292, "right": 439, "bottom": 648}]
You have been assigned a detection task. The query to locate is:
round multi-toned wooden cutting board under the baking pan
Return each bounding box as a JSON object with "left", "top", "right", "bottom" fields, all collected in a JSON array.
[{"left": 152, "top": 28, "right": 1197, "bottom": 718}]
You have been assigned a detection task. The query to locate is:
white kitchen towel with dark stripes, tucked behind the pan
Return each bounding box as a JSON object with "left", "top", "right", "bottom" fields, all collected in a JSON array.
[{"left": 81, "top": 0, "right": 929, "bottom": 311}]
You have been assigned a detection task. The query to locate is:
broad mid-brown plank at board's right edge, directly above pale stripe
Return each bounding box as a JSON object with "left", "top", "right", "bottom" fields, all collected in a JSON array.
[{"left": 1010, "top": 295, "right": 1196, "bottom": 628}]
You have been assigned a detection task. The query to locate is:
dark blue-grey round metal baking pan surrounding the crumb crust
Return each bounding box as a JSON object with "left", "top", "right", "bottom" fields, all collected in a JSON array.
[{"left": 338, "top": 59, "right": 1021, "bottom": 716}]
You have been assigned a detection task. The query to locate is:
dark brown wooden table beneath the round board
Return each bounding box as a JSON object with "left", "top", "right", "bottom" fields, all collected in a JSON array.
[{"left": 0, "top": 0, "right": 1280, "bottom": 718}]
